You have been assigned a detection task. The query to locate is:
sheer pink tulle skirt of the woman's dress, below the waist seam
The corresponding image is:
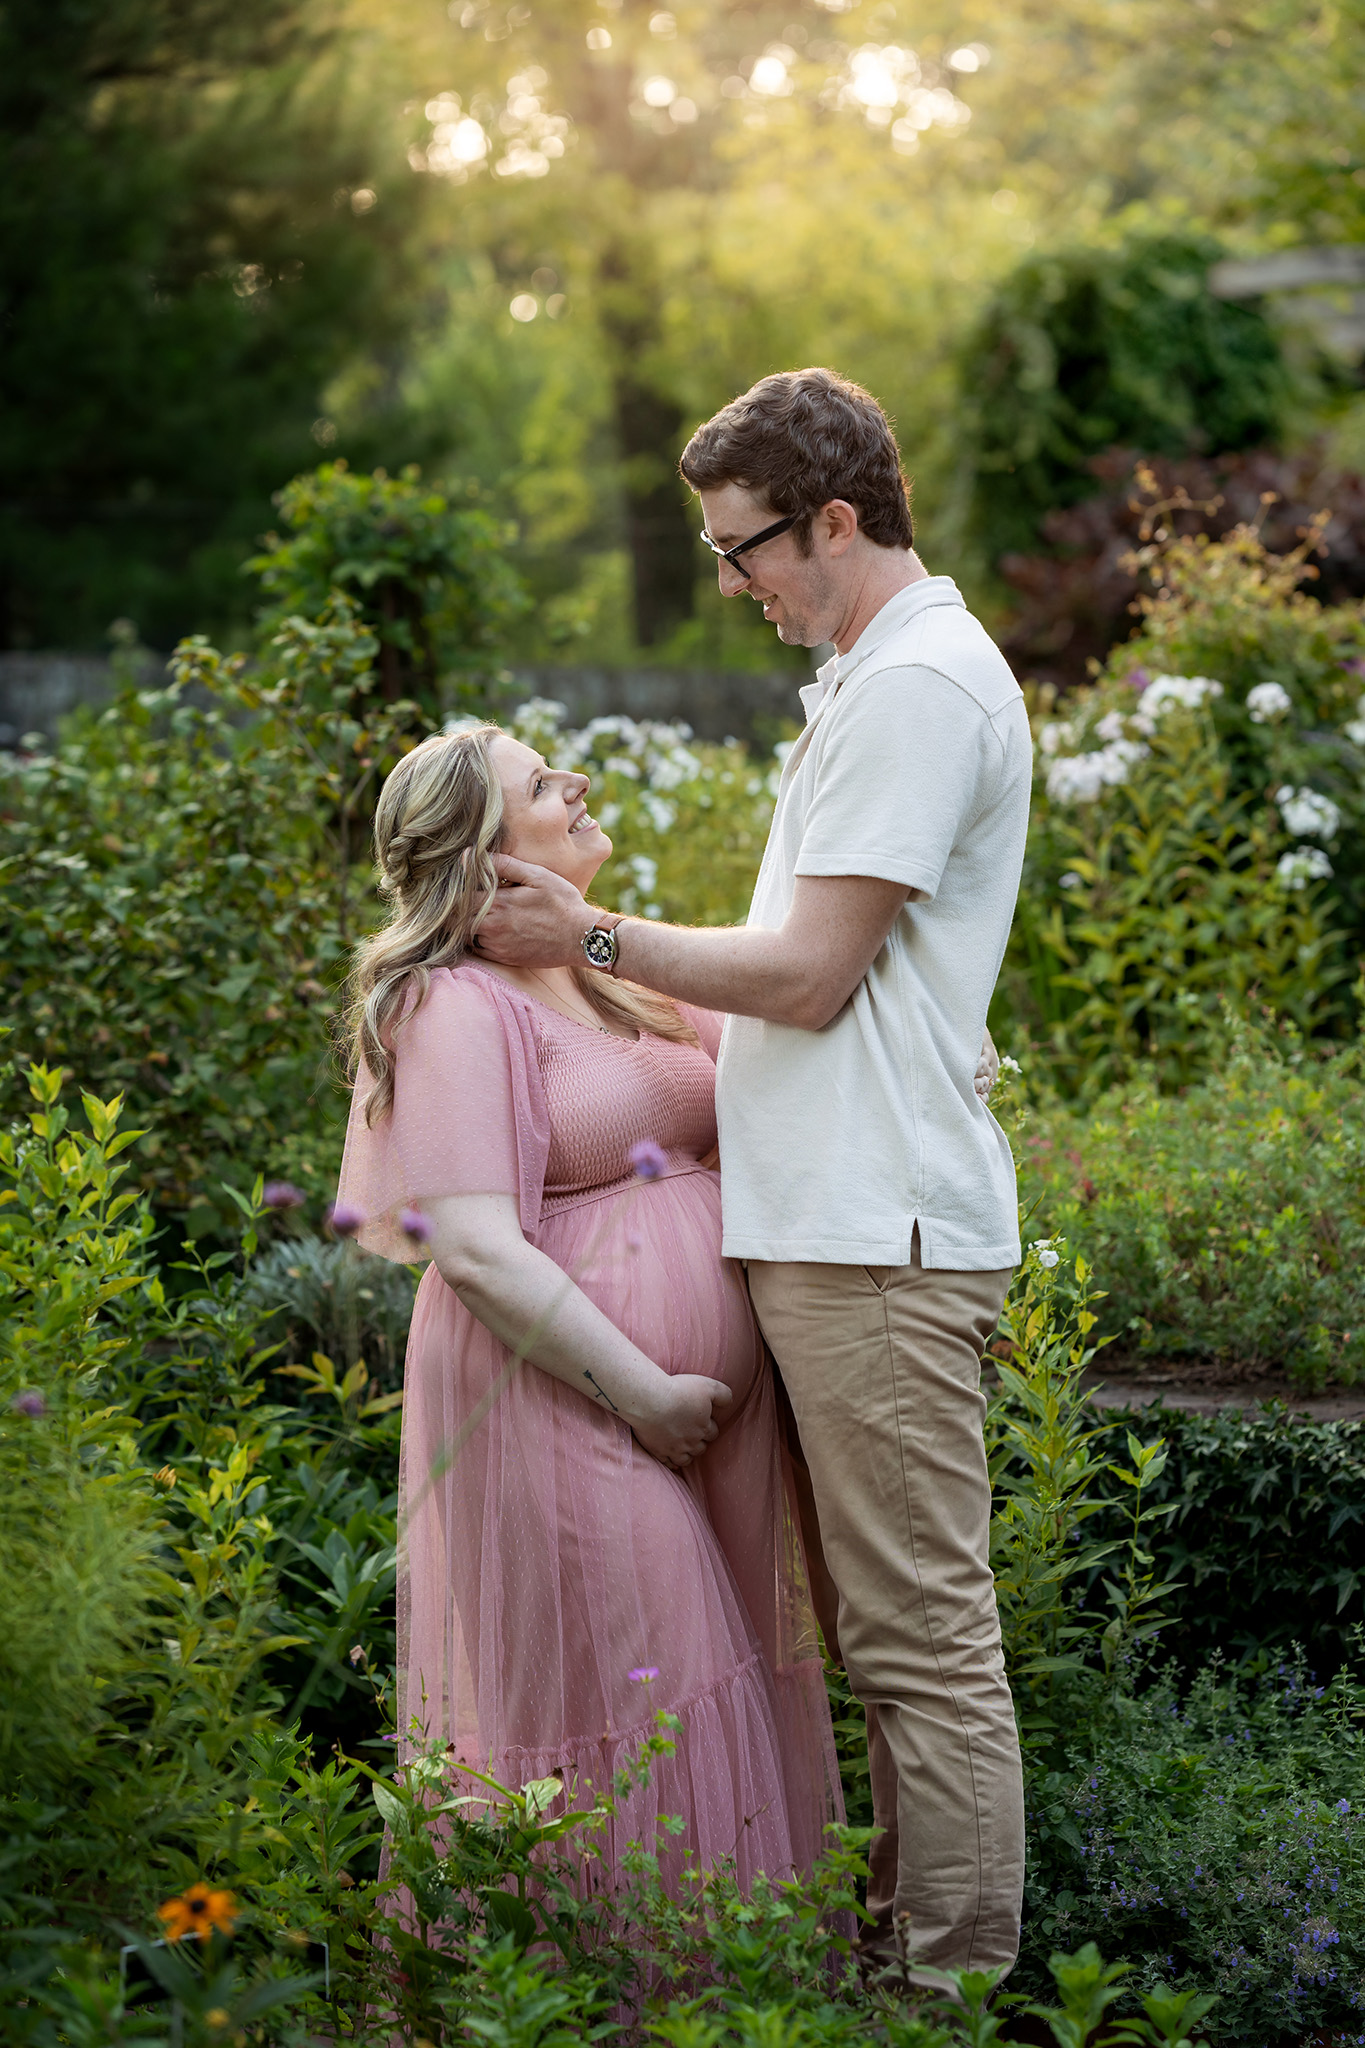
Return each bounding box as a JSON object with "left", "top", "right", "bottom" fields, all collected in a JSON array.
[{"left": 399, "top": 1165, "right": 843, "bottom": 1886}]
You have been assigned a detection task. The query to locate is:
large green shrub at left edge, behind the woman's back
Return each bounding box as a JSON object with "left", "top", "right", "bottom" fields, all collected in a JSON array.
[{"left": 0, "top": 596, "right": 411, "bottom": 1231}]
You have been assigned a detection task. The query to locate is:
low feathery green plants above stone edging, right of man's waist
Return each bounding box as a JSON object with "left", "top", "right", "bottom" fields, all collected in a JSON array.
[{"left": 1015, "top": 1020, "right": 1365, "bottom": 1386}]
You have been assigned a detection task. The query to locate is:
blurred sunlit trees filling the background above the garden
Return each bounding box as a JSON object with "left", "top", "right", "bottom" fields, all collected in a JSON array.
[{"left": 0, "top": 0, "right": 1365, "bottom": 662}]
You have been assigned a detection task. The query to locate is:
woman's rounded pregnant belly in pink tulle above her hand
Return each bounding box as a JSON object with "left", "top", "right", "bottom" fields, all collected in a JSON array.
[{"left": 540, "top": 1174, "right": 761, "bottom": 1401}]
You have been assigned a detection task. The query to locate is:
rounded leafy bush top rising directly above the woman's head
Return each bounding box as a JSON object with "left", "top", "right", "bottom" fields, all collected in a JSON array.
[{"left": 248, "top": 463, "right": 526, "bottom": 717}]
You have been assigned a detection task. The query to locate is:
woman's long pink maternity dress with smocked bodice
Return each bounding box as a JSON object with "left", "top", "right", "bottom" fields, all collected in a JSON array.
[{"left": 340, "top": 961, "right": 843, "bottom": 1886}]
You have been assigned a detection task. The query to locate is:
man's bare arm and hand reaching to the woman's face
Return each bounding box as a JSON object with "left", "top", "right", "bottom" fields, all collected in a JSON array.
[{"left": 477, "top": 854, "right": 921, "bottom": 1030}]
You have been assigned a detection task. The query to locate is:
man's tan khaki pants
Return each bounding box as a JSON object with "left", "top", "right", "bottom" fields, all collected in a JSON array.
[{"left": 749, "top": 1237, "right": 1023, "bottom": 1968}]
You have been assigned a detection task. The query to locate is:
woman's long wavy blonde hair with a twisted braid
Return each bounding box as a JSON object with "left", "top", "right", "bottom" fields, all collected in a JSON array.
[{"left": 346, "top": 723, "right": 698, "bottom": 1124}]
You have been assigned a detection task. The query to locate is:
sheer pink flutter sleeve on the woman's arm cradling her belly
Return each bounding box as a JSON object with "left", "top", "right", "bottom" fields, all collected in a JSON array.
[{"left": 338, "top": 969, "right": 548, "bottom": 1260}]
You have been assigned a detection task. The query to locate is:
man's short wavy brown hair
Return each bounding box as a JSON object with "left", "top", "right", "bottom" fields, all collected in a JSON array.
[{"left": 679, "top": 369, "right": 915, "bottom": 555}]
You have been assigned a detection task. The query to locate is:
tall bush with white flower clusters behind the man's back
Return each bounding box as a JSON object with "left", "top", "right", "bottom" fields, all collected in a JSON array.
[{"left": 997, "top": 512, "right": 1365, "bottom": 1094}]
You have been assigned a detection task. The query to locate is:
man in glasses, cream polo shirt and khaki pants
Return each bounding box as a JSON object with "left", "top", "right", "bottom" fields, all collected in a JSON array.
[{"left": 479, "top": 369, "right": 1031, "bottom": 1968}]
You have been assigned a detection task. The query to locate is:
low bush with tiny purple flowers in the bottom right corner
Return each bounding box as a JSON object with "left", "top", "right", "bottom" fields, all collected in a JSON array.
[{"left": 1017, "top": 1665, "right": 1365, "bottom": 2048}]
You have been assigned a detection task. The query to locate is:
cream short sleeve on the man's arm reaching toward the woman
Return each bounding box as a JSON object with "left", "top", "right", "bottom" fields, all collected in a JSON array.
[{"left": 796, "top": 668, "right": 1003, "bottom": 897}]
